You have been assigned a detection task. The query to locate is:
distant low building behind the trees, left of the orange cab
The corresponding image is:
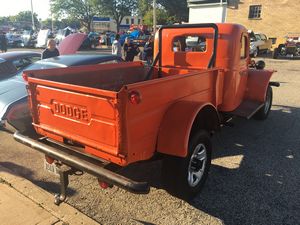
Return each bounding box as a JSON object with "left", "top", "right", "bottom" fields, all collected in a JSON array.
[{"left": 92, "top": 16, "right": 142, "bottom": 32}]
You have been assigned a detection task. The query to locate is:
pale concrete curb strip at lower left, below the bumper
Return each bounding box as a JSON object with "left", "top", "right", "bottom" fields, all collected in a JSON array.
[{"left": 0, "top": 163, "right": 99, "bottom": 225}]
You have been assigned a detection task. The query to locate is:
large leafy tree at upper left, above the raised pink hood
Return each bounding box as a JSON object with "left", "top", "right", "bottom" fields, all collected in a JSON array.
[{"left": 50, "top": 0, "right": 99, "bottom": 32}]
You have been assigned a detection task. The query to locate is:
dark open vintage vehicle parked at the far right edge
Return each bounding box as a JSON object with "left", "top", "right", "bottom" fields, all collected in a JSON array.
[{"left": 273, "top": 34, "right": 300, "bottom": 59}]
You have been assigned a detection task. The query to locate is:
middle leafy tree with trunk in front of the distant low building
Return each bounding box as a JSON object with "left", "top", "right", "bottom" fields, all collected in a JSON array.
[{"left": 99, "top": 0, "right": 137, "bottom": 32}]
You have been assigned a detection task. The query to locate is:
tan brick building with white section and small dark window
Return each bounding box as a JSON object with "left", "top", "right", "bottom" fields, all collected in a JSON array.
[{"left": 187, "top": 0, "right": 300, "bottom": 38}]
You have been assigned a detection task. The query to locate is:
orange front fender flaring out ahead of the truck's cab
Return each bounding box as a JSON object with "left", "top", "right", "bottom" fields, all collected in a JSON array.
[{"left": 245, "top": 69, "right": 275, "bottom": 102}]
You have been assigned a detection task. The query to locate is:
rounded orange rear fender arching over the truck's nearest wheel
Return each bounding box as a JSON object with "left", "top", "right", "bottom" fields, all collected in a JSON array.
[{"left": 157, "top": 101, "right": 220, "bottom": 157}]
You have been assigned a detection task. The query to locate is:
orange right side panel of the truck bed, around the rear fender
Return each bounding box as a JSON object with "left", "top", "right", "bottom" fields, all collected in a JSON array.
[{"left": 120, "top": 69, "right": 219, "bottom": 163}]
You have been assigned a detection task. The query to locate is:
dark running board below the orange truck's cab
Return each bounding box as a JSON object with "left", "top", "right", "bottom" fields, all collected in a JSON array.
[{"left": 228, "top": 100, "right": 264, "bottom": 119}]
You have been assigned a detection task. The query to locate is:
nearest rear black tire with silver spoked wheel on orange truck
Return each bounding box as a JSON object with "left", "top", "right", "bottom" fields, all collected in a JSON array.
[{"left": 162, "top": 130, "right": 212, "bottom": 200}]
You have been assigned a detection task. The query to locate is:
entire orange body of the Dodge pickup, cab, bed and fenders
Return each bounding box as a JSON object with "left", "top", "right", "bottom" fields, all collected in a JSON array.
[{"left": 24, "top": 24, "right": 272, "bottom": 166}]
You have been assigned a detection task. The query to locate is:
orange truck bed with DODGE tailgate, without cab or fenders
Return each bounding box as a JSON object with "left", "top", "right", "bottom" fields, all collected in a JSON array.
[{"left": 24, "top": 62, "right": 221, "bottom": 165}]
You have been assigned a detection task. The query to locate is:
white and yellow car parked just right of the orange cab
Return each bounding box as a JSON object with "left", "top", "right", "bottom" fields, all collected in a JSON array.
[{"left": 248, "top": 31, "right": 272, "bottom": 57}]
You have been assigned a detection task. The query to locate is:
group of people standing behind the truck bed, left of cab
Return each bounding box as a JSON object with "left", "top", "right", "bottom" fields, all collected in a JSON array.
[{"left": 112, "top": 34, "right": 154, "bottom": 65}]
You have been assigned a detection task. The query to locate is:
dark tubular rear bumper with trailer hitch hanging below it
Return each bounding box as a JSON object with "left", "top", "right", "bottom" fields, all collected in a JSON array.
[{"left": 14, "top": 131, "right": 150, "bottom": 205}]
